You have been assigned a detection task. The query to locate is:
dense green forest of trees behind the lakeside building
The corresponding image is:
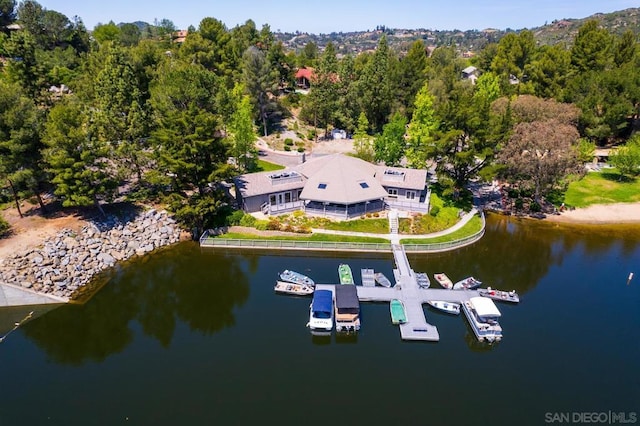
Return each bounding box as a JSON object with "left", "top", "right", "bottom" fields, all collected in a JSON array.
[{"left": 0, "top": 0, "right": 640, "bottom": 233}]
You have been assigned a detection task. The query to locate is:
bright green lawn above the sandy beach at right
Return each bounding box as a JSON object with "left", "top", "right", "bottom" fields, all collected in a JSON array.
[{"left": 564, "top": 170, "right": 640, "bottom": 207}]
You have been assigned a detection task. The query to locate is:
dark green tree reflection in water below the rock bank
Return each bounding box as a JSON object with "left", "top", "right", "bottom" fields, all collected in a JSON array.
[{"left": 24, "top": 243, "right": 249, "bottom": 365}]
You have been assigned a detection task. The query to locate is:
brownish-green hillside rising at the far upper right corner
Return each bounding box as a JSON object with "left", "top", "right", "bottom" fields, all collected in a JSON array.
[{"left": 531, "top": 8, "right": 640, "bottom": 45}]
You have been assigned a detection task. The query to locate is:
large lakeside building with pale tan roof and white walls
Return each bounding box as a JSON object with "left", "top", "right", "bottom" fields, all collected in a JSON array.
[{"left": 234, "top": 154, "right": 430, "bottom": 219}]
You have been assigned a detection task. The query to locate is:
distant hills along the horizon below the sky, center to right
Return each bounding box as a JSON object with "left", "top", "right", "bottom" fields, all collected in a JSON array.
[{"left": 275, "top": 8, "right": 640, "bottom": 55}]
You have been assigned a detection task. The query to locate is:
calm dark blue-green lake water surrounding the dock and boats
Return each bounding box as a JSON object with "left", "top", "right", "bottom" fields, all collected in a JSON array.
[{"left": 0, "top": 216, "right": 640, "bottom": 426}]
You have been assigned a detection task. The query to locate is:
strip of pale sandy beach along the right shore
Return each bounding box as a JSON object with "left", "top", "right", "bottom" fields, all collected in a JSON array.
[{"left": 545, "top": 203, "right": 640, "bottom": 225}]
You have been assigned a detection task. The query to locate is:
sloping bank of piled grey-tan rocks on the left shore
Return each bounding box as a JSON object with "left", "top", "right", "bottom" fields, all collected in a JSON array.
[{"left": 0, "top": 210, "right": 181, "bottom": 298}]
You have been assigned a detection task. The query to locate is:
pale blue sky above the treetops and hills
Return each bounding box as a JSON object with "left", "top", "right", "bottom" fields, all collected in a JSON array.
[{"left": 39, "top": 0, "right": 640, "bottom": 33}]
